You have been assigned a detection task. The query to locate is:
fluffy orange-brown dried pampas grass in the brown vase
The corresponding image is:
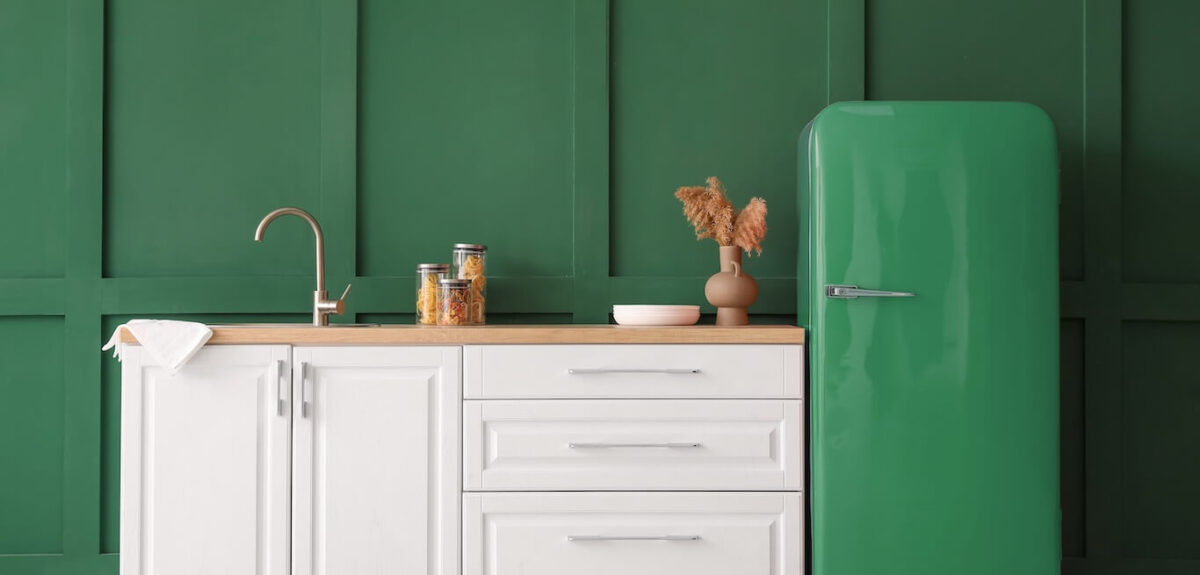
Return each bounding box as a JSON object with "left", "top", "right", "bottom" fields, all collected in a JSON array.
[{"left": 676, "top": 178, "right": 767, "bottom": 254}]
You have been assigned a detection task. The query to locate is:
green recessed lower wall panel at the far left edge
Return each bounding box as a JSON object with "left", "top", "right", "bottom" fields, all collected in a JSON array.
[{"left": 0, "top": 317, "right": 66, "bottom": 556}]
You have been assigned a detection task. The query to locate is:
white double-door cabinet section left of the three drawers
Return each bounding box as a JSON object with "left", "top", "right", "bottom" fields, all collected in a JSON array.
[{"left": 120, "top": 346, "right": 461, "bottom": 575}]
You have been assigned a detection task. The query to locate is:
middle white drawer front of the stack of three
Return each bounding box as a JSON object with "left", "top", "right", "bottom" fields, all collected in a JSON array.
[{"left": 463, "top": 400, "right": 804, "bottom": 491}]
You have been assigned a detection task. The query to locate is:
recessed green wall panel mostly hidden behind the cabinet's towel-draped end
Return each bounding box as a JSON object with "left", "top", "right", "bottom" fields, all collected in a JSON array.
[{"left": 100, "top": 313, "right": 311, "bottom": 553}]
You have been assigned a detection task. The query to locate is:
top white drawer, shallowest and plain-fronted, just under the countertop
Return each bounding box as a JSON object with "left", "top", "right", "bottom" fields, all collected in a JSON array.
[{"left": 463, "top": 345, "right": 804, "bottom": 399}]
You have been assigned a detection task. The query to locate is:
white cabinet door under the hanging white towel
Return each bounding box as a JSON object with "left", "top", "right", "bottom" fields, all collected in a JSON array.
[{"left": 120, "top": 346, "right": 290, "bottom": 575}]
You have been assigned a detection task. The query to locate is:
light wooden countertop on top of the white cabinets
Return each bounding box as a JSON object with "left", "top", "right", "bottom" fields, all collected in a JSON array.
[{"left": 121, "top": 324, "right": 804, "bottom": 346}]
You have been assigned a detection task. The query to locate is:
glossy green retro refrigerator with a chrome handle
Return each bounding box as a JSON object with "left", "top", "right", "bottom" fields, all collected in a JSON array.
[{"left": 799, "top": 102, "right": 1061, "bottom": 575}]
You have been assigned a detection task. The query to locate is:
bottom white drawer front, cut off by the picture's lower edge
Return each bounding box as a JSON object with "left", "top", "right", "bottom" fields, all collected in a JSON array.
[{"left": 462, "top": 493, "right": 804, "bottom": 575}]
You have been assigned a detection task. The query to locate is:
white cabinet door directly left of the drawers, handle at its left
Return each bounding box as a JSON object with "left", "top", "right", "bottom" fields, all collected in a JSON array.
[{"left": 292, "top": 347, "right": 461, "bottom": 575}]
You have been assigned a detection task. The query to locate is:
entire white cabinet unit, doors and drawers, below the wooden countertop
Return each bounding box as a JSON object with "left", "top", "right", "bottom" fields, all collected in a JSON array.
[{"left": 120, "top": 328, "right": 805, "bottom": 575}]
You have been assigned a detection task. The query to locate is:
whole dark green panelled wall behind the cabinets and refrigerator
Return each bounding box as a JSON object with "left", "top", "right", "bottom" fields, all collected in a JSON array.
[{"left": 0, "top": 0, "right": 1200, "bottom": 575}]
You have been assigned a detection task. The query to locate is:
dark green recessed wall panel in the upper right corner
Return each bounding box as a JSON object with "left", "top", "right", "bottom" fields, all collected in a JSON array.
[{"left": 1121, "top": 1, "right": 1200, "bottom": 282}]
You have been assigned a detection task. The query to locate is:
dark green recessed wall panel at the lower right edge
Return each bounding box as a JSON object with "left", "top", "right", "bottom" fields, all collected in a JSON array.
[{"left": 1112, "top": 322, "right": 1200, "bottom": 559}]
